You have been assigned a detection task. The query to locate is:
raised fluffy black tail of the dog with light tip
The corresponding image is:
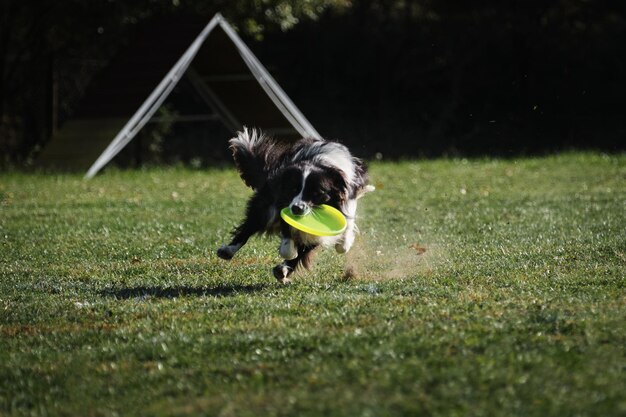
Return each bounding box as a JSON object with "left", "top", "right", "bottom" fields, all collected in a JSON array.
[{"left": 229, "top": 127, "right": 277, "bottom": 190}]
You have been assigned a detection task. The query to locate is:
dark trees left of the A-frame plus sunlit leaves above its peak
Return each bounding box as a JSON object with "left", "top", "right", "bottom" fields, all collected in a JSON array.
[{"left": 0, "top": 0, "right": 349, "bottom": 165}]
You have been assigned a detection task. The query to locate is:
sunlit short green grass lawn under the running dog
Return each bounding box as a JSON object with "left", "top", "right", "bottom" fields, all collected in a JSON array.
[{"left": 0, "top": 153, "right": 626, "bottom": 416}]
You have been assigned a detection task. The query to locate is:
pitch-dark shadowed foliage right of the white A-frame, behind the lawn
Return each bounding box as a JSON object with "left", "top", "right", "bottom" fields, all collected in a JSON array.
[{"left": 262, "top": 0, "right": 626, "bottom": 157}]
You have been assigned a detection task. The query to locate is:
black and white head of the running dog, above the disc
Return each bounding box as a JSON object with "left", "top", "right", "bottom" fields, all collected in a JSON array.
[{"left": 274, "top": 164, "right": 347, "bottom": 215}]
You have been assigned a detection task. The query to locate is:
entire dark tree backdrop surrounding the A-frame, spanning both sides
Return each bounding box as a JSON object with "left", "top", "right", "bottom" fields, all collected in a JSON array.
[{"left": 0, "top": 0, "right": 626, "bottom": 165}]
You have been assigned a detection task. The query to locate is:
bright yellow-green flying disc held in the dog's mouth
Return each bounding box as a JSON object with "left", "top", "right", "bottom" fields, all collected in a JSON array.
[{"left": 280, "top": 204, "right": 346, "bottom": 236}]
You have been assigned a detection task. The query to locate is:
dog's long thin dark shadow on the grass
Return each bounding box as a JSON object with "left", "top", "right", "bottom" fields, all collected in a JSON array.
[{"left": 100, "top": 284, "right": 268, "bottom": 300}]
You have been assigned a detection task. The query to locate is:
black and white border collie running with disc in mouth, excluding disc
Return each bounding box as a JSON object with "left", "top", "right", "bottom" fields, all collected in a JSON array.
[{"left": 217, "top": 128, "right": 374, "bottom": 283}]
